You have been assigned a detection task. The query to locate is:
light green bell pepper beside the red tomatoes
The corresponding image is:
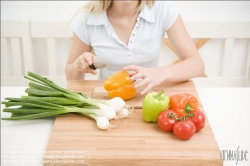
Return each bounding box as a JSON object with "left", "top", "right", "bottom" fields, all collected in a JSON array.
[{"left": 142, "top": 91, "right": 170, "bottom": 122}]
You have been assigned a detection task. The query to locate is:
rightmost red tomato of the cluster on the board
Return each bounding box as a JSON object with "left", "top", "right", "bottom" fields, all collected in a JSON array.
[{"left": 188, "top": 110, "right": 206, "bottom": 131}]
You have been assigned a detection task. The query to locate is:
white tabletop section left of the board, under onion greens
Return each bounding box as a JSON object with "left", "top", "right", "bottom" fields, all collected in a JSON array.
[{"left": 1, "top": 87, "right": 55, "bottom": 166}]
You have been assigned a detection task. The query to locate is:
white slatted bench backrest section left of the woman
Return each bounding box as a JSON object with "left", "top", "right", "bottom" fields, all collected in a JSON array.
[{"left": 1, "top": 21, "right": 97, "bottom": 86}]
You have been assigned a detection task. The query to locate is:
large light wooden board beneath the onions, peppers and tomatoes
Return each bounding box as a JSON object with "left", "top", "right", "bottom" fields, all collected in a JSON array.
[{"left": 43, "top": 81, "right": 223, "bottom": 166}]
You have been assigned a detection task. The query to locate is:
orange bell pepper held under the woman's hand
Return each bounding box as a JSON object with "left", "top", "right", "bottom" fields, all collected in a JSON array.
[{"left": 104, "top": 70, "right": 136, "bottom": 100}]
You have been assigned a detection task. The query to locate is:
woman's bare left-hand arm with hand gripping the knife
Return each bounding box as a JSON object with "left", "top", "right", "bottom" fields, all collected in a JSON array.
[{"left": 65, "top": 33, "right": 97, "bottom": 80}]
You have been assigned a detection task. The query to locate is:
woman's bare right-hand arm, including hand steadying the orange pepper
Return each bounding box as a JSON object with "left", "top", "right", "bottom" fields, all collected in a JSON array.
[{"left": 124, "top": 15, "right": 204, "bottom": 94}]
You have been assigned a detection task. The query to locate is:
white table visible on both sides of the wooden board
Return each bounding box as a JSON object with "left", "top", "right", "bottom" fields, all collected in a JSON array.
[{"left": 1, "top": 87, "right": 250, "bottom": 166}]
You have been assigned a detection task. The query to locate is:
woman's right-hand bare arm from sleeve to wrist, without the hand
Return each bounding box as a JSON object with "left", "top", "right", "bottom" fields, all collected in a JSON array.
[{"left": 165, "top": 15, "right": 204, "bottom": 82}]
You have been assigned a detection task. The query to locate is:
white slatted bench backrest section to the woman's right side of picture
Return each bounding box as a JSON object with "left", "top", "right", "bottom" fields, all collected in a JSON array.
[{"left": 164, "top": 22, "right": 250, "bottom": 86}]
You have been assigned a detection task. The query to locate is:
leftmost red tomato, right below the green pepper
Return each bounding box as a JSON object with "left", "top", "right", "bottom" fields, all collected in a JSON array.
[{"left": 158, "top": 110, "right": 177, "bottom": 131}]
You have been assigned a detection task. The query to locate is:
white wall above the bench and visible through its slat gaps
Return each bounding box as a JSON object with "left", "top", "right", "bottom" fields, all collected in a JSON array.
[{"left": 1, "top": 1, "right": 250, "bottom": 77}]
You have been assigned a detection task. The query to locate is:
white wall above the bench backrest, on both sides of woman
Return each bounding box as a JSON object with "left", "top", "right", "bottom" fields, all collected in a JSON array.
[{"left": 1, "top": 1, "right": 250, "bottom": 21}]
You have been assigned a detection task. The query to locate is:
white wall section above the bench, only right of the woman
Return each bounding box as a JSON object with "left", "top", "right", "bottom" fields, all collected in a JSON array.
[{"left": 173, "top": 1, "right": 250, "bottom": 21}]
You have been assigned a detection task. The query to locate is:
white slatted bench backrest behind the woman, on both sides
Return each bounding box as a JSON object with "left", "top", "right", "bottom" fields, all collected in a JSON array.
[{"left": 1, "top": 21, "right": 250, "bottom": 86}]
